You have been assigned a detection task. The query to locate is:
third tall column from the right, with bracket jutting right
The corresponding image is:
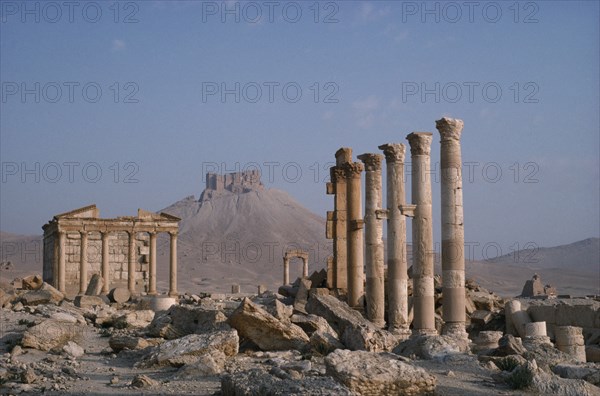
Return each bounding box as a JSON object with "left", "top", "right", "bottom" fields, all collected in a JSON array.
[{"left": 379, "top": 143, "right": 410, "bottom": 338}]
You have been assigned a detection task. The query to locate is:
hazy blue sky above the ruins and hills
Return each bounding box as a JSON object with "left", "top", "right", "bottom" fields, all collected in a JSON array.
[{"left": 0, "top": 1, "right": 600, "bottom": 256}]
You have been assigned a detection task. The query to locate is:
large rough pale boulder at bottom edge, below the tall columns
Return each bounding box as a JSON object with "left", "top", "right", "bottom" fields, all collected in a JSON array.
[{"left": 325, "top": 349, "right": 436, "bottom": 395}]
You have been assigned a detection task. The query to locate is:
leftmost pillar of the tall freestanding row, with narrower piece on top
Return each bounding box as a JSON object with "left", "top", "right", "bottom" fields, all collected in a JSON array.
[{"left": 330, "top": 147, "right": 352, "bottom": 290}]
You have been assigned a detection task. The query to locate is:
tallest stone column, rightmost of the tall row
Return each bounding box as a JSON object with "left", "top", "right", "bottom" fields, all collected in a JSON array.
[{"left": 435, "top": 117, "right": 467, "bottom": 336}]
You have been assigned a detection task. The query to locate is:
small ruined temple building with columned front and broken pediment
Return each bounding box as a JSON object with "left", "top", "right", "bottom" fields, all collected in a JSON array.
[{"left": 42, "top": 205, "right": 181, "bottom": 296}]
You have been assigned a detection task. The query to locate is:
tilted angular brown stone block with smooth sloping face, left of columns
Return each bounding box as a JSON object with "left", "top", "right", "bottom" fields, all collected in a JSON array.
[{"left": 228, "top": 298, "right": 309, "bottom": 350}]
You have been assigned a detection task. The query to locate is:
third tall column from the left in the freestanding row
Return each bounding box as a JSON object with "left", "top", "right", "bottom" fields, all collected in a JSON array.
[{"left": 358, "top": 153, "right": 385, "bottom": 327}]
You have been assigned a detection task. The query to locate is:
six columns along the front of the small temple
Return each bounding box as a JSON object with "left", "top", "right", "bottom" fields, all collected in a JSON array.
[{"left": 56, "top": 231, "right": 178, "bottom": 296}]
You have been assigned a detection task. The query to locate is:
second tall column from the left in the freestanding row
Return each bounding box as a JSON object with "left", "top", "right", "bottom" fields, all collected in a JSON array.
[{"left": 344, "top": 162, "right": 364, "bottom": 310}]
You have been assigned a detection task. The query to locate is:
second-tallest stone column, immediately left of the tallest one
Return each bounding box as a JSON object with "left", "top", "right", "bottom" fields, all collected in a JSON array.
[{"left": 406, "top": 132, "right": 437, "bottom": 334}]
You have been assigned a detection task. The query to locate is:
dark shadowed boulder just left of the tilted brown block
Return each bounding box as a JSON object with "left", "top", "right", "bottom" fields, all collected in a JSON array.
[{"left": 146, "top": 305, "right": 229, "bottom": 340}]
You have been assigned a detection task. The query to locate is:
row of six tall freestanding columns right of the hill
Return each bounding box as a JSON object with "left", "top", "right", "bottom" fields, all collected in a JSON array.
[{"left": 331, "top": 118, "right": 466, "bottom": 335}]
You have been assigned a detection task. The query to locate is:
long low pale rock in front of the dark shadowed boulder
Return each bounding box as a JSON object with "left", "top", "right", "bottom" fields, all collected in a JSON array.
[{"left": 136, "top": 330, "right": 240, "bottom": 367}]
